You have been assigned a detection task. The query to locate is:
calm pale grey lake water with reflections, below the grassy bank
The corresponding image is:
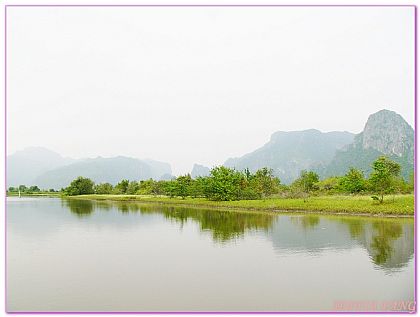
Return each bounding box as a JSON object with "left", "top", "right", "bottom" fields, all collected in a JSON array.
[{"left": 7, "top": 198, "right": 414, "bottom": 311}]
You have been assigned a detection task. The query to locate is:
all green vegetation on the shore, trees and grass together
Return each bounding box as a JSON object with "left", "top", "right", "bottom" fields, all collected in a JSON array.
[{"left": 9, "top": 156, "right": 414, "bottom": 215}]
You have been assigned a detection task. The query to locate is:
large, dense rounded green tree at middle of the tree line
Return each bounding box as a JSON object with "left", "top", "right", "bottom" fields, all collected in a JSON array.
[{"left": 206, "top": 166, "right": 243, "bottom": 200}]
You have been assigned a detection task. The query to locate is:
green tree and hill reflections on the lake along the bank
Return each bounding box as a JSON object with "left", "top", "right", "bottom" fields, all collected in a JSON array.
[{"left": 63, "top": 199, "right": 414, "bottom": 268}]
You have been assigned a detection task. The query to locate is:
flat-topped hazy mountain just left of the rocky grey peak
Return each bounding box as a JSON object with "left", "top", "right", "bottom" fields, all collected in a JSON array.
[{"left": 224, "top": 129, "right": 354, "bottom": 184}]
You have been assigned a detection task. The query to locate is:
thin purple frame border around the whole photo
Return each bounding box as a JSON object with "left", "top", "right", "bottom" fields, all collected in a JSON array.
[{"left": 4, "top": 4, "right": 417, "bottom": 315}]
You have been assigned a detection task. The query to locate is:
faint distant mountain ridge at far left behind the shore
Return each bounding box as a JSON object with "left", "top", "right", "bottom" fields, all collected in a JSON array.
[{"left": 7, "top": 148, "right": 172, "bottom": 189}]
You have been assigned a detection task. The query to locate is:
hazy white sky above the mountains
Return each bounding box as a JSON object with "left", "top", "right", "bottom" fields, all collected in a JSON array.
[{"left": 7, "top": 7, "right": 414, "bottom": 174}]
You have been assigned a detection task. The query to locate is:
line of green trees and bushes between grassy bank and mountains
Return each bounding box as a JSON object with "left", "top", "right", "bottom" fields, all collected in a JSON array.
[{"left": 9, "top": 156, "right": 414, "bottom": 202}]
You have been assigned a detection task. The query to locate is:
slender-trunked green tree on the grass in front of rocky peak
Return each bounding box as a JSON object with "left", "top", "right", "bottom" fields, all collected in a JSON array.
[{"left": 369, "top": 156, "right": 401, "bottom": 203}]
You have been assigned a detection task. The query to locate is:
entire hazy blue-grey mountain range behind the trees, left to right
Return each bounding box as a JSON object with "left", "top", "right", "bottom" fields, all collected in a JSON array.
[{"left": 7, "top": 110, "right": 414, "bottom": 189}]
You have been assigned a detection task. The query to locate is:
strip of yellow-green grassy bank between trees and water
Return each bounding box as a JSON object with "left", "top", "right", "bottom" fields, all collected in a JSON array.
[{"left": 68, "top": 195, "right": 414, "bottom": 216}]
